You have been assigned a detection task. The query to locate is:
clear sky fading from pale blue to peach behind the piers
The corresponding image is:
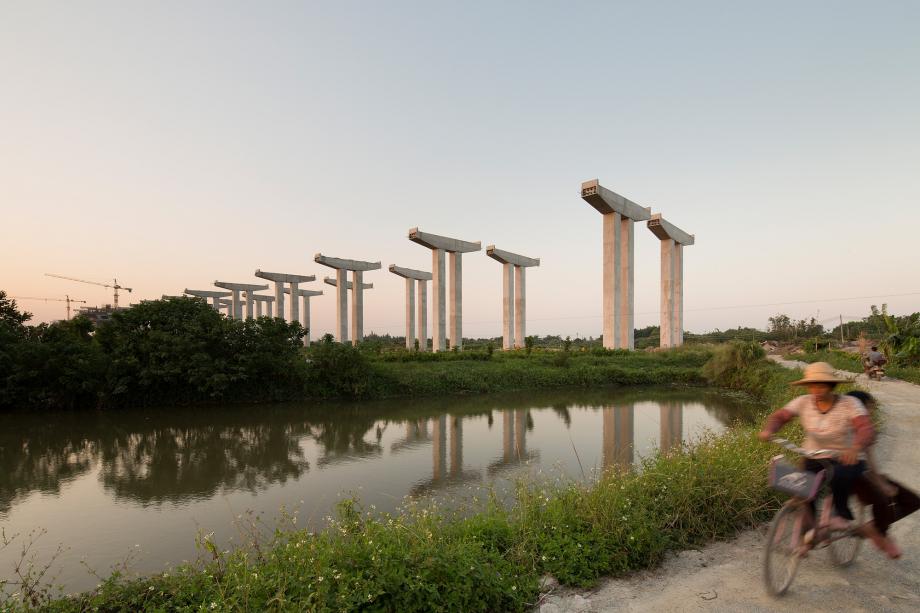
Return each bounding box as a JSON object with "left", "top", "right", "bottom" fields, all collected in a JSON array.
[{"left": 0, "top": 0, "right": 920, "bottom": 337}]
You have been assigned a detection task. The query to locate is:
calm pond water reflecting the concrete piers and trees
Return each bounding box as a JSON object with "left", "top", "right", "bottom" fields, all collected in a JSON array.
[{"left": 0, "top": 389, "right": 749, "bottom": 591}]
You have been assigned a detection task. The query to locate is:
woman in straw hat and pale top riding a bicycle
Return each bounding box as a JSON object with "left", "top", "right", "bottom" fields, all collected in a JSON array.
[{"left": 758, "top": 362, "right": 904, "bottom": 555}]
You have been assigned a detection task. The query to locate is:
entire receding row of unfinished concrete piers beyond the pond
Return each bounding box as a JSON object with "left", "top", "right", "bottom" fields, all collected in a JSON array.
[{"left": 185, "top": 179, "right": 694, "bottom": 351}]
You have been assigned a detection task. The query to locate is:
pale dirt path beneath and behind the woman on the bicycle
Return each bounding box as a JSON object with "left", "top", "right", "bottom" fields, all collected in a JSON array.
[{"left": 540, "top": 359, "right": 920, "bottom": 613}]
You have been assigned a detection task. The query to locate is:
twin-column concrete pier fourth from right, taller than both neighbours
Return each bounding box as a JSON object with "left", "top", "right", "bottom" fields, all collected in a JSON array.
[{"left": 409, "top": 228, "right": 482, "bottom": 351}]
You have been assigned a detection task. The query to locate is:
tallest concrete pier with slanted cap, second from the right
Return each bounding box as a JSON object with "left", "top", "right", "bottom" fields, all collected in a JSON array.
[{"left": 581, "top": 179, "right": 652, "bottom": 349}]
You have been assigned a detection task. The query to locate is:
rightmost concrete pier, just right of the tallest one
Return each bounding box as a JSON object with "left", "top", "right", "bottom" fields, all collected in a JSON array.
[{"left": 648, "top": 213, "right": 695, "bottom": 347}]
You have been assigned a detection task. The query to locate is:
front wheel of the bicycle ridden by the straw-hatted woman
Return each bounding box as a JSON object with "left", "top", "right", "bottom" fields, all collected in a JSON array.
[{"left": 763, "top": 504, "right": 806, "bottom": 596}]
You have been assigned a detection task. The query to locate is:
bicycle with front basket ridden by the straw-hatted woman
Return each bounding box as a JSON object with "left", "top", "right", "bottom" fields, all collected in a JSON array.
[{"left": 764, "top": 437, "right": 865, "bottom": 596}]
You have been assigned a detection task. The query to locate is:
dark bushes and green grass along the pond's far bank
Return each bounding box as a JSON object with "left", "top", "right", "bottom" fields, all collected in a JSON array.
[{"left": 0, "top": 292, "right": 710, "bottom": 410}]
